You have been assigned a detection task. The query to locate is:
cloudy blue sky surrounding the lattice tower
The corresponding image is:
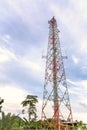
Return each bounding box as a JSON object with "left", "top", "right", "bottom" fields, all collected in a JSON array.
[{"left": 0, "top": 0, "right": 87, "bottom": 122}]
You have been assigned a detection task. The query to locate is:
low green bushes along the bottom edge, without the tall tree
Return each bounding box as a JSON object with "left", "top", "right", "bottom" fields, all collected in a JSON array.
[{"left": 0, "top": 112, "right": 87, "bottom": 130}]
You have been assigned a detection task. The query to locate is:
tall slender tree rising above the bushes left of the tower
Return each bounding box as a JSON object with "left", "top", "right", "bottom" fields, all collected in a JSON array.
[{"left": 21, "top": 95, "right": 38, "bottom": 122}]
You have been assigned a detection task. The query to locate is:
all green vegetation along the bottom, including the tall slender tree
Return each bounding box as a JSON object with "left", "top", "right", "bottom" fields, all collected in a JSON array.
[{"left": 0, "top": 95, "right": 87, "bottom": 130}]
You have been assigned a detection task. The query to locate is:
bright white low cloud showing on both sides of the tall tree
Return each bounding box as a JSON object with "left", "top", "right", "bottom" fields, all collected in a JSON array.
[{"left": 0, "top": 84, "right": 42, "bottom": 119}]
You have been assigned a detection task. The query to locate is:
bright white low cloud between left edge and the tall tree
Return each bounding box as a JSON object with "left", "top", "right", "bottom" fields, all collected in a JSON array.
[{"left": 0, "top": 84, "right": 28, "bottom": 113}]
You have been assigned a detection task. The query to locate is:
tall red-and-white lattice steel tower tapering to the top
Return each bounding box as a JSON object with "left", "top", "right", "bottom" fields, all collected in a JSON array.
[{"left": 41, "top": 17, "right": 73, "bottom": 130}]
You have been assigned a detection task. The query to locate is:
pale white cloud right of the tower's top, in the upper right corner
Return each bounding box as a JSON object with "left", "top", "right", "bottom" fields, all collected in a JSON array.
[{"left": 50, "top": 1, "right": 87, "bottom": 53}]
